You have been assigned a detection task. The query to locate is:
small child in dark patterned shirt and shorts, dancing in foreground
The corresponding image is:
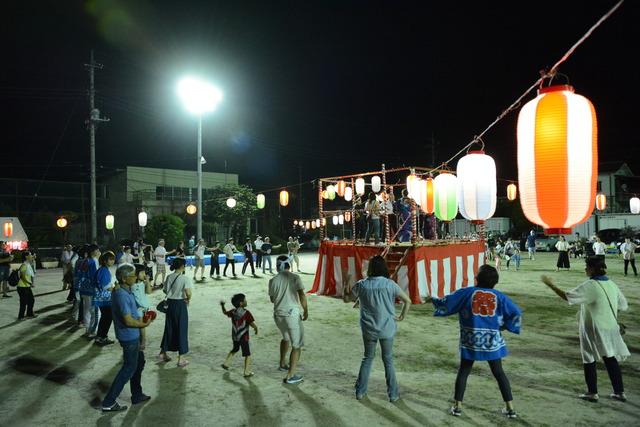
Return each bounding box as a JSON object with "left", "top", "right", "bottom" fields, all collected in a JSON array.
[{"left": 220, "top": 294, "right": 258, "bottom": 378}]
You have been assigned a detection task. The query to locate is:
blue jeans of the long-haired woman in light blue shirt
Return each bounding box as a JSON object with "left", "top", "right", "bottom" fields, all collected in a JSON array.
[{"left": 356, "top": 335, "right": 398, "bottom": 400}]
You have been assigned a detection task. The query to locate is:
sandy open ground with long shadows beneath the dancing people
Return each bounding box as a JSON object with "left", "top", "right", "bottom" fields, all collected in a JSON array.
[{"left": 0, "top": 254, "right": 640, "bottom": 427}]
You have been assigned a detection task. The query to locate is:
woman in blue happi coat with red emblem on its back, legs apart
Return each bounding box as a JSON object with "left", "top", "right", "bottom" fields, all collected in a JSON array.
[{"left": 431, "top": 265, "right": 521, "bottom": 418}]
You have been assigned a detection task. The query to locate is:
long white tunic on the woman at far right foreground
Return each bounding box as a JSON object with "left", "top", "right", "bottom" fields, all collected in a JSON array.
[{"left": 566, "top": 279, "right": 630, "bottom": 363}]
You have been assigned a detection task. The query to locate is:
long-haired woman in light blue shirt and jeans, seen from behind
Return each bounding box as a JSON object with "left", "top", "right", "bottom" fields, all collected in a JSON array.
[{"left": 342, "top": 255, "right": 411, "bottom": 402}]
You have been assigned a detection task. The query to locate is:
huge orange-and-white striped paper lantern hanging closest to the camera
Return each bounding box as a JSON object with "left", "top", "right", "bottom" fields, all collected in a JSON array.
[{"left": 518, "top": 85, "right": 598, "bottom": 234}]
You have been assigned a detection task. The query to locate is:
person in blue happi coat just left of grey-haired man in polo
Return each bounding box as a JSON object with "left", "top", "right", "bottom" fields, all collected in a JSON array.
[{"left": 93, "top": 248, "right": 116, "bottom": 346}]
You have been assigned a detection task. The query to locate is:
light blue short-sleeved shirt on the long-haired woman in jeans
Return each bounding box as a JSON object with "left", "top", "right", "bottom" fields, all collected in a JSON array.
[{"left": 351, "top": 276, "right": 401, "bottom": 339}]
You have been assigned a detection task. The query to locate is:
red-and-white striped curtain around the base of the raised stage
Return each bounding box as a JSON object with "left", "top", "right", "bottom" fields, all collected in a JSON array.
[{"left": 309, "top": 240, "right": 485, "bottom": 304}]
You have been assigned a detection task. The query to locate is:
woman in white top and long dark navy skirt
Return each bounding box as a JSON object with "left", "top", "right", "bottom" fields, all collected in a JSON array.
[{"left": 158, "top": 258, "right": 193, "bottom": 368}]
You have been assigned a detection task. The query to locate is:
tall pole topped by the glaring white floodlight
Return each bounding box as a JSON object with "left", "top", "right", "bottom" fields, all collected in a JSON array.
[{"left": 178, "top": 77, "right": 222, "bottom": 239}]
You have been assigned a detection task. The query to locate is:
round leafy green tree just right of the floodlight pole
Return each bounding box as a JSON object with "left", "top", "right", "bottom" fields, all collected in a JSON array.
[{"left": 204, "top": 184, "right": 258, "bottom": 242}]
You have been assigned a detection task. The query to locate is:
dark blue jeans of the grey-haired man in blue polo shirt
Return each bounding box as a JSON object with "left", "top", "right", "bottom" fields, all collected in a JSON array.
[{"left": 102, "top": 339, "right": 146, "bottom": 408}]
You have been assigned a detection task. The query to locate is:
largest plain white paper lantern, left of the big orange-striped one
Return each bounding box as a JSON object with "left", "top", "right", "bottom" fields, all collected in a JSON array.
[{"left": 456, "top": 151, "right": 498, "bottom": 222}]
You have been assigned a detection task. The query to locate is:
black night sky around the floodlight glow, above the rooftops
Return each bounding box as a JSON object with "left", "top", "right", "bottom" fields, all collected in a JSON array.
[{"left": 0, "top": 0, "right": 640, "bottom": 195}]
